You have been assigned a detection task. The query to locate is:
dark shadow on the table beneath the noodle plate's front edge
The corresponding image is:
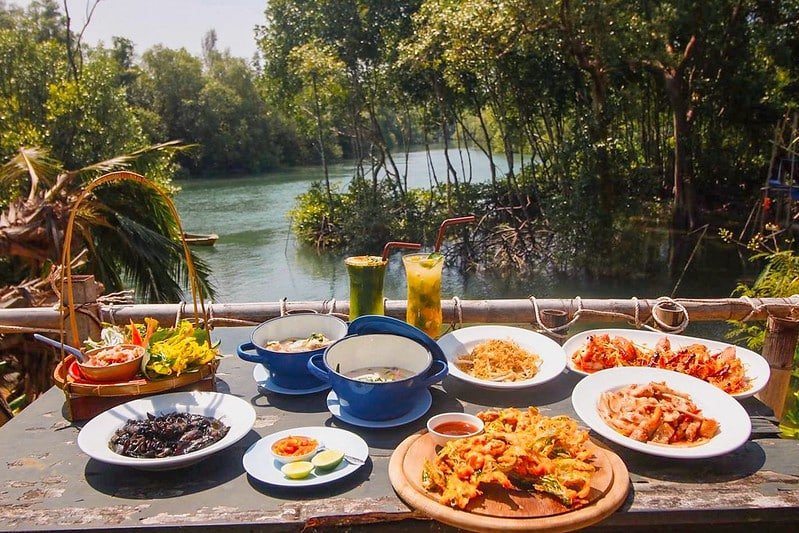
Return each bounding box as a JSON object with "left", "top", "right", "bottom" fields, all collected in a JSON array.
[{"left": 443, "top": 372, "right": 583, "bottom": 408}]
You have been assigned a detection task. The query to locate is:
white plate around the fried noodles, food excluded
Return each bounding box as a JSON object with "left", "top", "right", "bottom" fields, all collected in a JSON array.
[{"left": 438, "top": 326, "right": 566, "bottom": 390}]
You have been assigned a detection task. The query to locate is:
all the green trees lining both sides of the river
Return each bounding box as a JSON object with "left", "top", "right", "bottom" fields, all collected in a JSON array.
[{"left": 0, "top": 0, "right": 799, "bottom": 282}]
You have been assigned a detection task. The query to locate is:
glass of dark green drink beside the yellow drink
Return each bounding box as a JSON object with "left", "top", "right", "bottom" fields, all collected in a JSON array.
[{"left": 344, "top": 255, "right": 388, "bottom": 320}]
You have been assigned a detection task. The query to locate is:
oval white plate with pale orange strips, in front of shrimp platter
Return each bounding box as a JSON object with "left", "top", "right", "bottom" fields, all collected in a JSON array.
[{"left": 572, "top": 367, "right": 752, "bottom": 459}]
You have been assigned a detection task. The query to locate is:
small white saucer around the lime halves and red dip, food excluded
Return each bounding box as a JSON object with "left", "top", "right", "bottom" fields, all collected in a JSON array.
[{"left": 243, "top": 427, "right": 369, "bottom": 487}]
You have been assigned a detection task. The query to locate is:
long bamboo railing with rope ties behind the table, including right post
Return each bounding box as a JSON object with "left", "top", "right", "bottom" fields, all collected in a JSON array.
[{"left": 0, "top": 286, "right": 799, "bottom": 416}]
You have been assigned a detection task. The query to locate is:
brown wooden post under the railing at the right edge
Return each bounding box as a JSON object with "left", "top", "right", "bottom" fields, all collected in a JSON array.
[{"left": 757, "top": 316, "right": 799, "bottom": 418}]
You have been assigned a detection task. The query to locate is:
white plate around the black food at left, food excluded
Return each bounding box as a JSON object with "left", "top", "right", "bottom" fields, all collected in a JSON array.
[{"left": 78, "top": 392, "right": 255, "bottom": 470}]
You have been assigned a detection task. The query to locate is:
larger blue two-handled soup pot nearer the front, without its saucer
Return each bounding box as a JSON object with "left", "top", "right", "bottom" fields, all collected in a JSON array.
[{"left": 308, "top": 333, "right": 448, "bottom": 421}]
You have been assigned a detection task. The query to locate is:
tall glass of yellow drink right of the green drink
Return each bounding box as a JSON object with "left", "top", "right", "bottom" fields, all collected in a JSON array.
[{"left": 402, "top": 253, "right": 444, "bottom": 338}]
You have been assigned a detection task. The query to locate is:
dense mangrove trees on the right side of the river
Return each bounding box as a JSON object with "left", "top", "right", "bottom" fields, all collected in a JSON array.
[{"left": 276, "top": 0, "right": 799, "bottom": 275}]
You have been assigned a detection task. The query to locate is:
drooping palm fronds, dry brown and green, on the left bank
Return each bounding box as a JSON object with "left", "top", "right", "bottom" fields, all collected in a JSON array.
[{"left": 0, "top": 147, "right": 214, "bottom": 302}]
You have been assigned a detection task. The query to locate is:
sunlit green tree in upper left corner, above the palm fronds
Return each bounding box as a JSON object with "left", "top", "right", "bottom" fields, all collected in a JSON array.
[{"left": 0, "top": 6, "right": 147, "bottom": 168}]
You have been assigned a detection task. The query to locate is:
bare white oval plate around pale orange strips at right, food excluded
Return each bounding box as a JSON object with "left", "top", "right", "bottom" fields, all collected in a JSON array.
[{"left": 572, "top": 366, "right": 752, "bottom": 459}]
